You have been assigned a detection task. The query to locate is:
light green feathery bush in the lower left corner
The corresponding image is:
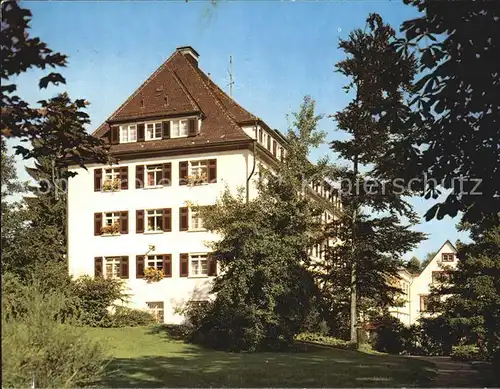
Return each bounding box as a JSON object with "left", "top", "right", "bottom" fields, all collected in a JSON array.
[{"left": 2, "top": 275, "right": 106, "bottom": 388}]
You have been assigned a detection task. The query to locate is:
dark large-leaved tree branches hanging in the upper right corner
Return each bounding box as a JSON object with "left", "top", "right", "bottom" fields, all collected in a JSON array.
[{"left": 380, "top": 0, "right": 500, "bottom": 223}]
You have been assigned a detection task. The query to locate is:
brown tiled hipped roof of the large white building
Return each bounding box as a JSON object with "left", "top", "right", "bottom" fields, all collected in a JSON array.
[{"left": 93, "top": 47, "right": 258, "bottom": 152}]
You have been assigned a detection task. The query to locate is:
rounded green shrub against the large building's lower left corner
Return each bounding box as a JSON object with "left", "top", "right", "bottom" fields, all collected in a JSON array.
[{"left": 71, "top": 276, "right": 128, "bottom": 327}]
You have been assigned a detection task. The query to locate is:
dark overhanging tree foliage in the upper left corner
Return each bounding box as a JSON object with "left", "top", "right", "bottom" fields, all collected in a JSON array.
[{"left": 0, "top": 0, "right": 108, "bottom": 167}]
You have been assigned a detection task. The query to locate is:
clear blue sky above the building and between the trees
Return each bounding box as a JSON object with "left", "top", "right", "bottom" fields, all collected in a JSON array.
[{"left": 11, "top": 0, "right": 467, "bottom": 259}]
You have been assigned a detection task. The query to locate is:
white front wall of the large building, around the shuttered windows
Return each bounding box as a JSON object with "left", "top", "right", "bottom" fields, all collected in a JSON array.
[{"left": 68, "top": 151, "right": 255, "bottom": 323}]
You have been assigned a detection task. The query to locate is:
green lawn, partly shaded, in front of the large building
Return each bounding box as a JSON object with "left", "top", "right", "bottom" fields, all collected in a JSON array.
[{"left": 89, "top": 327, "right": 435, "bottom": 388}]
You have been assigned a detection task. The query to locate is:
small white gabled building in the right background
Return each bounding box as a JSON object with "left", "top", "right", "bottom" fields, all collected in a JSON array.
[{"left": 390, "top": 240, "right": 457, "bottom": 325}]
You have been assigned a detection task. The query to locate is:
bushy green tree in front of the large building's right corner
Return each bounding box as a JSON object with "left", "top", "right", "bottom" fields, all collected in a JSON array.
[{"left": 187, "top": 97, "right": 326, "bottom": 351}]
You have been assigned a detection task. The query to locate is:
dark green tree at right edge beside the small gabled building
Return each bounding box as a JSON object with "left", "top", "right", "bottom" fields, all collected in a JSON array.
[{"left": 433, "top": 220, "right": 500, "bottom": 362}]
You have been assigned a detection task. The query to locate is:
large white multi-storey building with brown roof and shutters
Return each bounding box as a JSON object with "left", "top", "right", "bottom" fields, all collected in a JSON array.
[{"left": 68, "top": 46, "right": 340, "bottom": 323}]
